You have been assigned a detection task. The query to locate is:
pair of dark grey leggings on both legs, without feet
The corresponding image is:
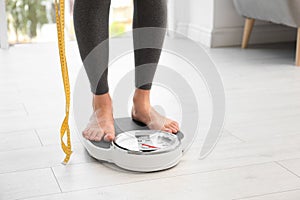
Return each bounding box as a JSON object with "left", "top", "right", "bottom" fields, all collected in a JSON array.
[{"left": 73, "top": 0, "right": 167, "bottom": 95}]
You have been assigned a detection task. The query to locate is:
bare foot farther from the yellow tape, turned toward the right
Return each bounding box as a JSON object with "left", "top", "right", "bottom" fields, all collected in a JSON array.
[{"left": 132, "top": 89, "right": 179, "bottom": 133}]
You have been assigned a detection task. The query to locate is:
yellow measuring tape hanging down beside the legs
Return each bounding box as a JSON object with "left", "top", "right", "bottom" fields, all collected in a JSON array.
[{"left": 55, "top": 0, "right": 72, "bottom": 164}]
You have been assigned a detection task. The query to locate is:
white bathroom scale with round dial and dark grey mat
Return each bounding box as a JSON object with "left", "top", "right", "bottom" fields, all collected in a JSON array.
[{"left": 80, "top": 117, "right": 184, "bottom": 172}]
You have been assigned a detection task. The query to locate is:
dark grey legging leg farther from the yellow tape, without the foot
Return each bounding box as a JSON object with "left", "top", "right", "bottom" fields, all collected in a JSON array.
[{"left": 133, "top": 0, "right": 167, "bottom": 90}]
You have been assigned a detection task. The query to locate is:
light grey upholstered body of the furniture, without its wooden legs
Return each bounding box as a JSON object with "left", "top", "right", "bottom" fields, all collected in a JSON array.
[{"left": 234, "top": 0, "right": 300, "bottom": 27}]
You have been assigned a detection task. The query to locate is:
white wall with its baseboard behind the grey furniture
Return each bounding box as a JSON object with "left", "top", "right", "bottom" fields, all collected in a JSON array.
[{"left": 174, "top": 0, "right": 296, "bottom": 47}]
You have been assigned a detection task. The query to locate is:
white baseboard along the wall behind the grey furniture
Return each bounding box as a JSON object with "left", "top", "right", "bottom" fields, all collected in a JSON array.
[{"left": 176, "top": 23, "right": 297, "bottom": 47}]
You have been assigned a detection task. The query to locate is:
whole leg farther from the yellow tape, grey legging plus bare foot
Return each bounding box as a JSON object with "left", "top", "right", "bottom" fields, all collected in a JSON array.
[{"left": 132, "top": 0, "right": 179, "bottom": 133}]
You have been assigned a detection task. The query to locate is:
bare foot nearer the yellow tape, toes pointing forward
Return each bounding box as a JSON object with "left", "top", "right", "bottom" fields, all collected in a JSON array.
[{"left": 82, "top": 94, "right": 115, "bottom": 141}]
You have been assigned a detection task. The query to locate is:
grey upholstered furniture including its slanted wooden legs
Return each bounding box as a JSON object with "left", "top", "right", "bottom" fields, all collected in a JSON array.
[{"left": 234, "top": 0, "right": 300, "bottom": 66}]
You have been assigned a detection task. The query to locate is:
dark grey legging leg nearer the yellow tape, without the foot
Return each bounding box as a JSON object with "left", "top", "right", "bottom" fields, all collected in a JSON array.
[{"left": 73, "top": 0, "right": 111, "bottom": 95}]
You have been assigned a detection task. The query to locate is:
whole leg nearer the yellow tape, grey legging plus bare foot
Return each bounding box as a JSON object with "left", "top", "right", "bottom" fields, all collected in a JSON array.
[{"left": 73, "top": 0, "right": 114, "bottom": 141}]
